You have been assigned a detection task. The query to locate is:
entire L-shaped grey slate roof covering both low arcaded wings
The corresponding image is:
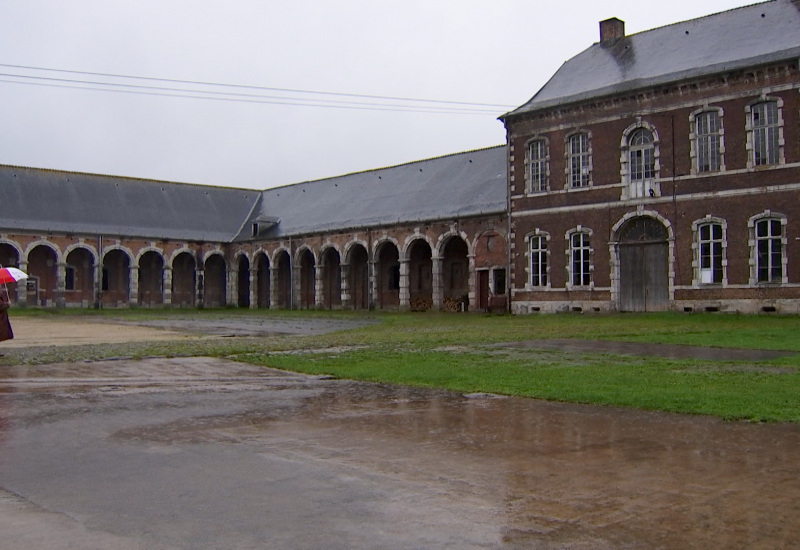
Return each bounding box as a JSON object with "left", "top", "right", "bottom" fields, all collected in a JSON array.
[{"left": 0, "top": 146, "right": 506, "bottom": 242}]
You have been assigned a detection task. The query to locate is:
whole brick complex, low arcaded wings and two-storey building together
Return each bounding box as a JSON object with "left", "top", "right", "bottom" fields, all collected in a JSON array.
[{"left": 0, "top": 0, "right": 800, "bottom": 313}]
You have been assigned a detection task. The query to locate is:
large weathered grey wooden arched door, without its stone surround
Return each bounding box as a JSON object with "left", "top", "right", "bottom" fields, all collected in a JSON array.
[{"left": 619, "top": 218, "right": 669, "bottom": 311}]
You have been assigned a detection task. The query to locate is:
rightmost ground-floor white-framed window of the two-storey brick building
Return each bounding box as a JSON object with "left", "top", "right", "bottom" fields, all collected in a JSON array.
[{"left": 748, "top": 210, "right": 788, "bottom": 284}]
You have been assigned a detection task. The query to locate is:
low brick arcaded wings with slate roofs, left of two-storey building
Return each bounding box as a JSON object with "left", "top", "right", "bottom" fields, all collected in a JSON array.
[{"left": 0, "top": 147, "right": 508, "bottom": 310}]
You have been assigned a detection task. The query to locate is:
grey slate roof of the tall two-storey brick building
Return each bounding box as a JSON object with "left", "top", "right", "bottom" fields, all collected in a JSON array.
[{"left": 501, "top": 0, "right": 800, "bottom": 119}]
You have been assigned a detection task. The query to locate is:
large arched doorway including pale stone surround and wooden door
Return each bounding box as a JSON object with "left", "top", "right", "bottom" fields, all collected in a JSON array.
[{"left": 609, "top": 208, "right": 675, "bottom": 311}]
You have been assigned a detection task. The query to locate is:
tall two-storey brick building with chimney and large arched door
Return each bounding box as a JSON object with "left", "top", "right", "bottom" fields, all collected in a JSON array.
[{"left": 501, "top": 0, "right": 800, "bottom": 313}]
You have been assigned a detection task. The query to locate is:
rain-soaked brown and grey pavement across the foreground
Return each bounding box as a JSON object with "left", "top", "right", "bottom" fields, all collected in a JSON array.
[{"left": 0, "top": 358, "right": 800, "bottom": 550}]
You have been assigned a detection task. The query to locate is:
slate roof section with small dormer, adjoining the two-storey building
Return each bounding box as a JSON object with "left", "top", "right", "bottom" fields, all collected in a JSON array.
[{"left": 234, "top": 146, "right": 507, "bottom": 243}]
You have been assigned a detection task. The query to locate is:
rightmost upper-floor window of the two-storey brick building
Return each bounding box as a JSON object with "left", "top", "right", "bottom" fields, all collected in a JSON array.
[{"left": 745, "top": 98, "right": 784, "bottom": 168}]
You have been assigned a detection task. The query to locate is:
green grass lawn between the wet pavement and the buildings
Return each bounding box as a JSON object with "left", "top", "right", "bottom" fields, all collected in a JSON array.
[{"left": 4, "top": 309, "right": 800, "bottom": 422}]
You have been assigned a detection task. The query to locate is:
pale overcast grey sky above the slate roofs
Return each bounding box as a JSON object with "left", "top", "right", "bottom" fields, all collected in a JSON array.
[{"left": 0, "top": 0, "right": 753, "bottom": 189}]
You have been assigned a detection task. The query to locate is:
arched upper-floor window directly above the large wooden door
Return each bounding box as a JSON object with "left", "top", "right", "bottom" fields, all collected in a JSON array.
[{"left": 620, "top": 120, "right": 661, "bottom": 200}]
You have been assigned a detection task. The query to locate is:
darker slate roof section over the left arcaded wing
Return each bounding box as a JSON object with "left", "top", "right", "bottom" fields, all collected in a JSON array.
[{"left": 0, "top": 166, "right": 261, "bottom": 242}]
